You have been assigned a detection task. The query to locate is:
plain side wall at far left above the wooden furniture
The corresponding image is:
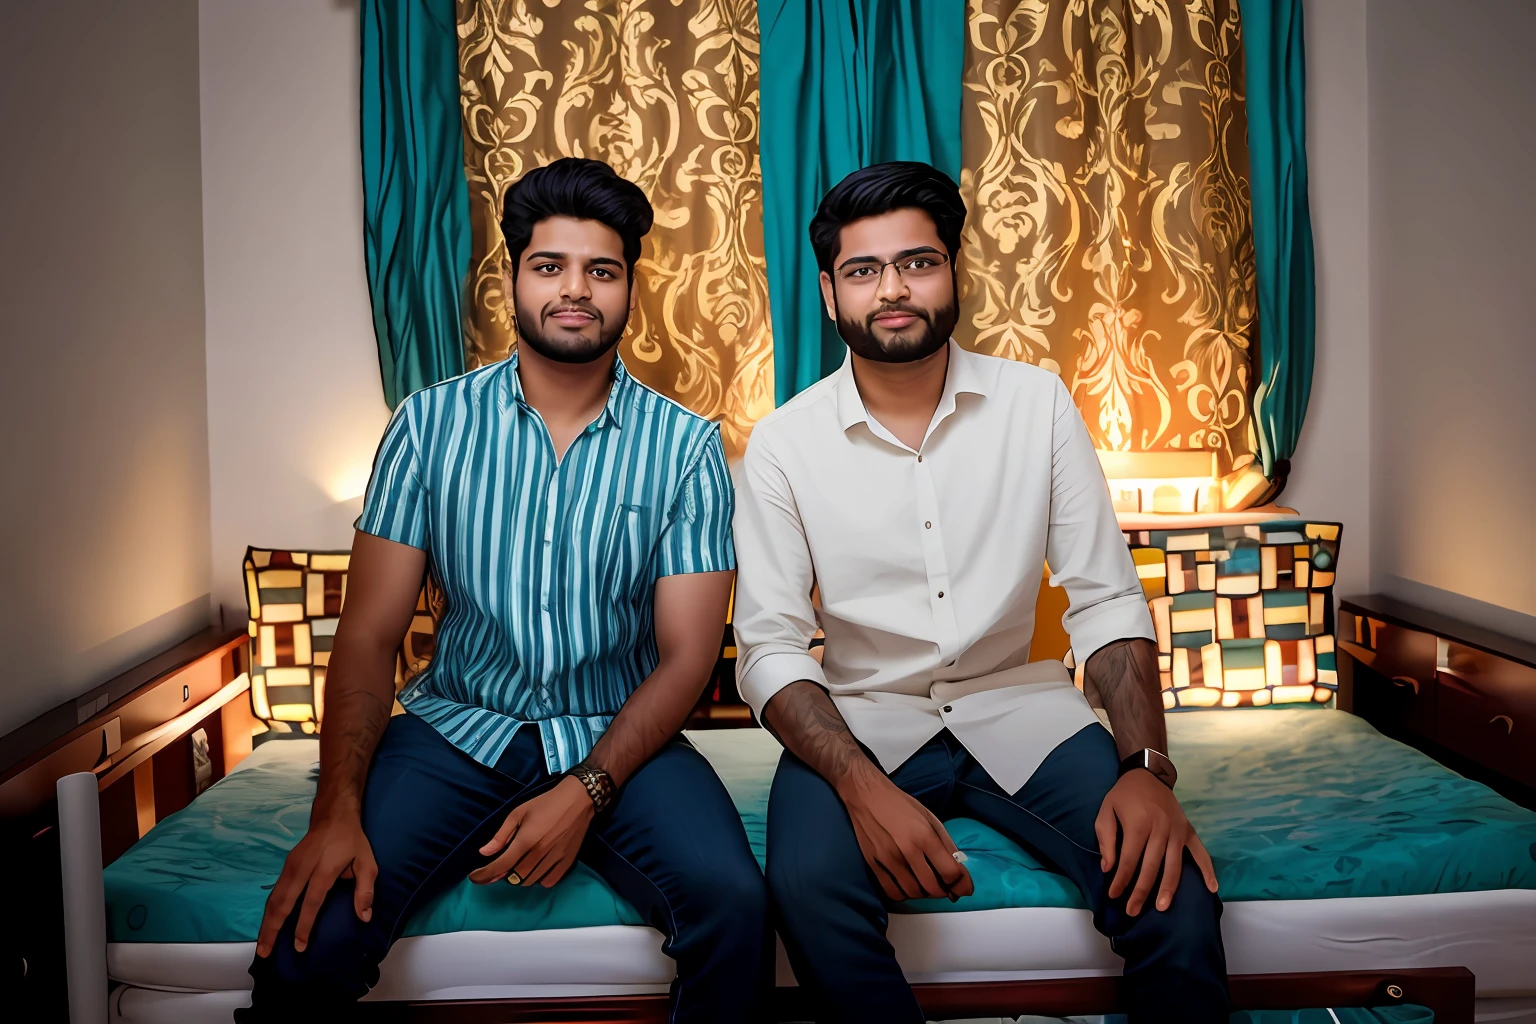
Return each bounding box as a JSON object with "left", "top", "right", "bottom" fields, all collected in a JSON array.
[{"left": 0, "top": 0, "right": 209, "bottom": 734}]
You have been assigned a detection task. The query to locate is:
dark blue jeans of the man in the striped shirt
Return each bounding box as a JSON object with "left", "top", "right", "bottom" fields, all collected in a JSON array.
[{"left": 240, "top": 714, "right": 773, "bottom": 1024}]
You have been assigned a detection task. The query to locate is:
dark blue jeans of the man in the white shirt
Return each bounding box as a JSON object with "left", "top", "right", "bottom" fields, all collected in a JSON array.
[{"left": 768, "top": 725, "right": 1227, "bottom": 1024}]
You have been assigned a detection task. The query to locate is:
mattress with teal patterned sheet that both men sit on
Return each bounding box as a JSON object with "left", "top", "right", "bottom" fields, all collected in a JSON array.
[{"left": 96, "top": 708, "right": 1536, "bottom": 1024}]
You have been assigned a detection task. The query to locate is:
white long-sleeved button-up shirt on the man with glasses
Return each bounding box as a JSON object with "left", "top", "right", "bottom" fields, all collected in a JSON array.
[{"left": 734, "top": 341, "right": 1155, "bottom": 792}]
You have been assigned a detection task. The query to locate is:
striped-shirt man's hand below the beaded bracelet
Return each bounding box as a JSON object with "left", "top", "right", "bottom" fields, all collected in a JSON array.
[{"left": 470, "top": 775, "right": 594, "bottom": 889}]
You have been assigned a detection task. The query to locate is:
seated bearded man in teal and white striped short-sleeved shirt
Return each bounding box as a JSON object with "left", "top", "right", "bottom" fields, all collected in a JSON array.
[{"left": 244, "top": 160, "right": 771, "bottom": 1021}]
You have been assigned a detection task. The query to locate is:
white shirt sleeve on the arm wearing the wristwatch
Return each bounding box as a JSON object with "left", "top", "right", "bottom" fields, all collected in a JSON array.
[{"left": 1046, "top": 381, "right": 1157, "bottom": 665}]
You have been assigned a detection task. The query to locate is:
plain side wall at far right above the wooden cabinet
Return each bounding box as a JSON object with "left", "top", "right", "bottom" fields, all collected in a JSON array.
[{"left": 1367, "top": 0, "right": 1536, "bottom": 640}]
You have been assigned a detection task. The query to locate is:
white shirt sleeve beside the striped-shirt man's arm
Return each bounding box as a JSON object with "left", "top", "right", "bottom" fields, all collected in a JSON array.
[{"left": 733, "top": 430, "right": 826, "bottom": 722}]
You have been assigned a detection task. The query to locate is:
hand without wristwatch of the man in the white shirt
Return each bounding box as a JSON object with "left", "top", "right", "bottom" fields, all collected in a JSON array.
[{"left": 837, "top": 760, "right": 975, "bottom": 901}]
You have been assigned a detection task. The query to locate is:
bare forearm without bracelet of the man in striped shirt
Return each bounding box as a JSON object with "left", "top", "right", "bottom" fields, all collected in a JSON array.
[{"left": 313, "top": 649, "right": 395, "bottom": 817}]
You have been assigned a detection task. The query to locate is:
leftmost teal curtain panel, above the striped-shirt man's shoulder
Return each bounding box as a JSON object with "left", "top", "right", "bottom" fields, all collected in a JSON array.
[{"left": 362, "top": 0, "right": 470, "bottom": 408}]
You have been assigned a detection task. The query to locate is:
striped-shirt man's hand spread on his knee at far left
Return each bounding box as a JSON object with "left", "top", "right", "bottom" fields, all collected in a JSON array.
[{"left": 257, "top": 812, "right": 379, "bottom": 956}]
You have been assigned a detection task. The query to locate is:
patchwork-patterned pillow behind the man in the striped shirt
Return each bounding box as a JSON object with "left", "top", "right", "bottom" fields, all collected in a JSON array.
[{"left": 244, "top": 548, "right": 442, "bottom": 732}]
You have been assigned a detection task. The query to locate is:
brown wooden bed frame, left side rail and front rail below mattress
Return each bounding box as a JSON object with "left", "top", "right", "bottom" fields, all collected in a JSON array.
[{"left": 0, "top": 629, "right": 1475, "bottom": 1024}]
